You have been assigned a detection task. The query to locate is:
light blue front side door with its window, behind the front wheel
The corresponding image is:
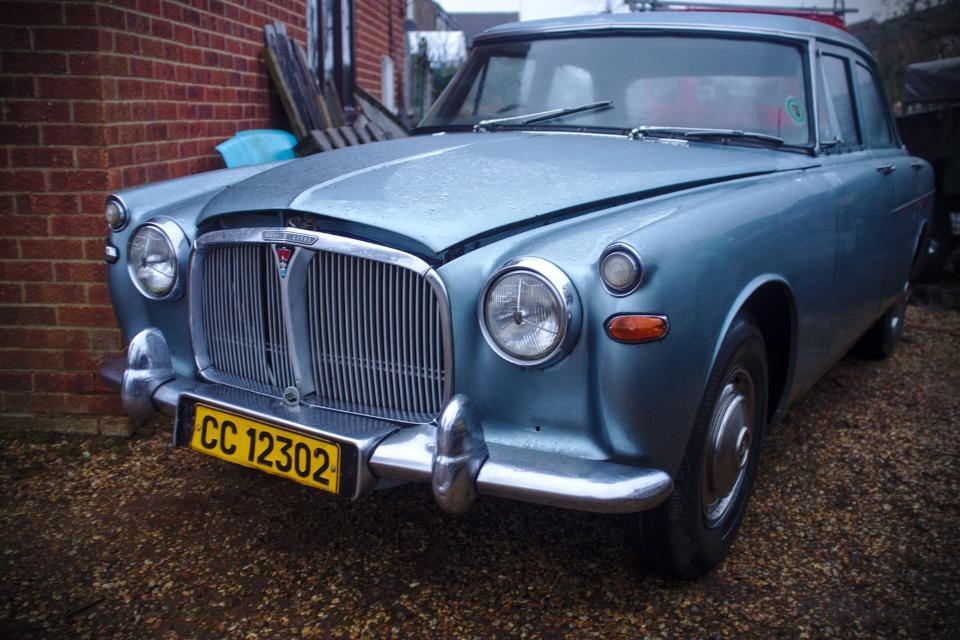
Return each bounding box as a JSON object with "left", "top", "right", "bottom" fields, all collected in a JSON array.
[{"left": 817, "top": 46, "right": 893, "bottom": 357}]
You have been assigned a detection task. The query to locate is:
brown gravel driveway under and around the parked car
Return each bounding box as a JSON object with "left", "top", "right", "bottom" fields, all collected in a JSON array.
[{"left": 0, "top": 298, "right": 960, "bottom": 638}]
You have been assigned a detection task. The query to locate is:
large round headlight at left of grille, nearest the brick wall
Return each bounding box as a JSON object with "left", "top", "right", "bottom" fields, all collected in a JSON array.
[{"left": 127, "top": 218, "right": 189, "bottom": 299}]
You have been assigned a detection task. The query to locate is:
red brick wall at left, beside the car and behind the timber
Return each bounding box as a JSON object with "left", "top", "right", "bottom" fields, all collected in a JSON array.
[{"left": 0, "top": 0, "right": 403, "bottom": 431}]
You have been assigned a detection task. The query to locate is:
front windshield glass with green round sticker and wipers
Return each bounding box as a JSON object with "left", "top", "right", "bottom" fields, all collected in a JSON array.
[{"left": 420, "top": 35, "right": 810, "bottom": 145}]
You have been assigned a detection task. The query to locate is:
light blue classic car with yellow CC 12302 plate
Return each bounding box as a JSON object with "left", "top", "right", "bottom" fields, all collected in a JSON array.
[{"left": 102, "top": 12, "right": 933, "bottom": 578}]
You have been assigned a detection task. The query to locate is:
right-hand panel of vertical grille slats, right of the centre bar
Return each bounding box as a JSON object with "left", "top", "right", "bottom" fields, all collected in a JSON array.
[{"left": 307, "top": 252, "right": 443, "bottom": 416}]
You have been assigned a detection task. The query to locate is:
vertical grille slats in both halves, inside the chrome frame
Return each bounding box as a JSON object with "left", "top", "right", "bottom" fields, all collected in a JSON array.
[{"left": 197, "top": 243, "right": 447, "bottom": 421}]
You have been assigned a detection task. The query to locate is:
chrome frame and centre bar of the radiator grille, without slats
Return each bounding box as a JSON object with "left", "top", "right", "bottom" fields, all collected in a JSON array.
[{"left": 187, "top": 227, "right": 454, "bottom": 424}]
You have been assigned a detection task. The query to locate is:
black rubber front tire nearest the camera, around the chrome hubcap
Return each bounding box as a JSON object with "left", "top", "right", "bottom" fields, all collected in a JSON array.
[{"left": 640, "top": 313, "right": 768, "bottom": 580}]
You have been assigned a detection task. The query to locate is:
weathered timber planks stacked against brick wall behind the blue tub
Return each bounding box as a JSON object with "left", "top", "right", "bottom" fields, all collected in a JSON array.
[{"left": 263, "top": 22, "right": 409, "bottom": 156}]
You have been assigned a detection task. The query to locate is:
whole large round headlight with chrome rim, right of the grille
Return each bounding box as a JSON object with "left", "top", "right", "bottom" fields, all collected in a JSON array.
[{"left": 479, "top": 258, "right": 580, "bottom": 366}]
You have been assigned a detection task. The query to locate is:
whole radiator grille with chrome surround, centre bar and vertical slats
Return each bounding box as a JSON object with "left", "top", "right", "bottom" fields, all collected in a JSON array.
[{"left": 190, "top": 228, "right": 453, "bottom": 424}]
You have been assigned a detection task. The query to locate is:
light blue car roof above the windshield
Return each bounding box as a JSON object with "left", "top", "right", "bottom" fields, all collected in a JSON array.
[{"left": 474, "top": 11, "right": 869, "bottom": 55}]
